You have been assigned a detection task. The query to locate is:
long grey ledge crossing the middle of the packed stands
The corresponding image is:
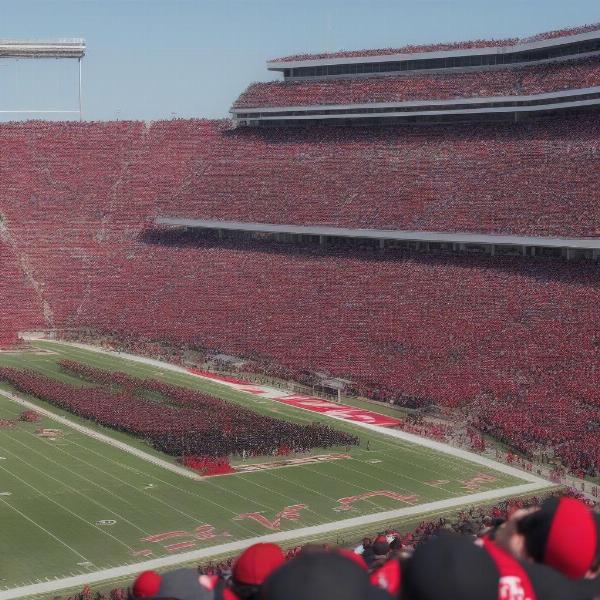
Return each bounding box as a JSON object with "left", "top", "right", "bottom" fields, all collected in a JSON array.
[{"left": 154, "top": 217, "right": 600, "bottom": 250}]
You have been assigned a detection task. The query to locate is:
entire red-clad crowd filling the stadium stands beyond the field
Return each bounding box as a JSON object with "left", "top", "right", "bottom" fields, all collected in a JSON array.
[{"left": 0, "top": 27, "right": 600, "bottom": 472}]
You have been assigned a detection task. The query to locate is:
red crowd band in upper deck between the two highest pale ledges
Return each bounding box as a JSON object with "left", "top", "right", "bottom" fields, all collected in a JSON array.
[{"left": 234, "top": 57, "right": 600, "bottom": 108}]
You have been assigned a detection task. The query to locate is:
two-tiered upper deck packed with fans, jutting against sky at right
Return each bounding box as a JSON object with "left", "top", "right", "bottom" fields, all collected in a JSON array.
[{"left": 231, "top": 25, "right": 600, "bottom": 126}]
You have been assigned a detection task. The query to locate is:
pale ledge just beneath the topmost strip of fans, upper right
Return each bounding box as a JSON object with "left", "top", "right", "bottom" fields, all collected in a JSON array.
[{"left": 267, "top": 29, "right": 600, "bottom": 71}]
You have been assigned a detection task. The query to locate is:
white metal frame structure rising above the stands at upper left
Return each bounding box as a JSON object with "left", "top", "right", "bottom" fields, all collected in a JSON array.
[{"left": 0, "top": 38, "right": 86, "bottom": 121}]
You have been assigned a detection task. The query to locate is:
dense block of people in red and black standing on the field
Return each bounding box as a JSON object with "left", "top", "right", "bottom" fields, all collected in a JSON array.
[{"left": 0, "top": 363, "right": 358, "bottom": 460}]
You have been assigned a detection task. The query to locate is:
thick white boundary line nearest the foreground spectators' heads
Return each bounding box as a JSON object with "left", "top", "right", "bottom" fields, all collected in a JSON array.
[{"left": 0, "top": 482, "right": 548, "bottom": 600}]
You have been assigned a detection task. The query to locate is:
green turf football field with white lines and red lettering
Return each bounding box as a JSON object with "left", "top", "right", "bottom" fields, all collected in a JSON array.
[{"left": 0, "top": 342, "right": 548, "bottom": 599}]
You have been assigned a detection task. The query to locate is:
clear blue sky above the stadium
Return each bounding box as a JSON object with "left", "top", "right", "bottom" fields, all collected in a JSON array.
[{"left": 0, "top": 0, "right": 600, "bottom": 120}]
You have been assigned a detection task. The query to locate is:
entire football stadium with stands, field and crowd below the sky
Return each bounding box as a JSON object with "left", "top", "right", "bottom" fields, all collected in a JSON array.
[{"left": 0, "top": 8, "right": 600, "bottom": 600}]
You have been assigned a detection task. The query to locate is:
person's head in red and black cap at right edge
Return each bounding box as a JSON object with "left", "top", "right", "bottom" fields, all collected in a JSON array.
[{"left": 496, "top": 497, "right": 600, "bottom": 579}]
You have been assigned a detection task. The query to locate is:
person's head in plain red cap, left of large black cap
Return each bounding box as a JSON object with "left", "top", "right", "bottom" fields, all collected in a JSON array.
[{"left": 231, "top": 544, "right": 285, "bottom": 600}]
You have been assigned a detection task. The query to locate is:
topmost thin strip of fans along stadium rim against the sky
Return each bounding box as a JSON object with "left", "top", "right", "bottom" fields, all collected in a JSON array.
[{"left": 273, "top": 23, "right": 600, "bottom": 62}]
